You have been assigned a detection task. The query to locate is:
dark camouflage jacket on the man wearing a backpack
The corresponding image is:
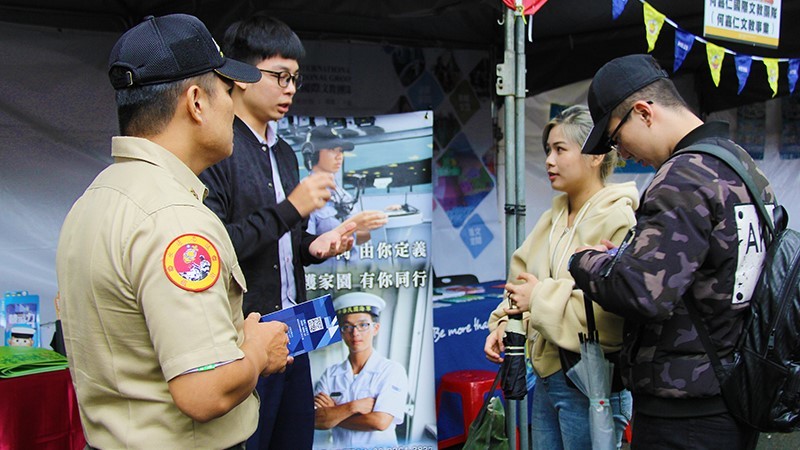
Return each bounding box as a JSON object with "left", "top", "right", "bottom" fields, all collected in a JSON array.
[{"left": 570, "top": 122, "right": 774, "bottom": 417}]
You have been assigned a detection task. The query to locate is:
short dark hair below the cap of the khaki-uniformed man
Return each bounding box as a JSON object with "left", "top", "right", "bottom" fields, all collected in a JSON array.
[{"left": 117, "top": 72, "right": 217, "bottom": 136}]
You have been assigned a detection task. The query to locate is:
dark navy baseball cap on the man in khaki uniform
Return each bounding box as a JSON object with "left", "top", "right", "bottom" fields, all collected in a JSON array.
[{"left": 108, "top": 14, "right": 261, "bottom": 89}]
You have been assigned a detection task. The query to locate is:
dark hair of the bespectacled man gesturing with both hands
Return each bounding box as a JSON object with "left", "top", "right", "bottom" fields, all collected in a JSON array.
[{"left": 222, "top": 13, "right": 306, "bottom": 65}]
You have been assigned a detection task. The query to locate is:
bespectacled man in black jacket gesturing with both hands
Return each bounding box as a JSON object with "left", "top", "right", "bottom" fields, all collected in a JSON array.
[{"left": 201, "top": 14, "right": 355, "bottom": 449}]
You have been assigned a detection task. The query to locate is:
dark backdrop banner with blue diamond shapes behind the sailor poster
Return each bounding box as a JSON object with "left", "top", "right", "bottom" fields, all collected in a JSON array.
[{"left": 292, "top": 40, "right": 505, "bottom": 282}]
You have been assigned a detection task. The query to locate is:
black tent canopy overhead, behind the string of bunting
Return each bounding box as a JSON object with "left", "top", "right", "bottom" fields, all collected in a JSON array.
[{"left": 0, "top": 0, "right": 800, "bottom": 112}]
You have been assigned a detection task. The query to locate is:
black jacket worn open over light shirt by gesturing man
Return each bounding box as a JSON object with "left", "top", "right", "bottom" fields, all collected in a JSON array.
[{"left": 200, "top": 117, "right": 323, "bottom": 317}]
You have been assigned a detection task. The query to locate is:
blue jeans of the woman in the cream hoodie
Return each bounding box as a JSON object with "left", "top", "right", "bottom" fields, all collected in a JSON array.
[{"left": 531, "top": 370, "right": 633, "bottom": 450}]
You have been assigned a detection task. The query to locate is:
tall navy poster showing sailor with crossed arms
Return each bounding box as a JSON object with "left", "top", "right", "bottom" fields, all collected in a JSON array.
[{"left": 278, "top": 111, "right": 436, "bottom": 449}]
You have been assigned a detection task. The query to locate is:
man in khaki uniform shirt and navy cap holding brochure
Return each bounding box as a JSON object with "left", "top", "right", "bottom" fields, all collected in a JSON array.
[{"left": 57, "top": 14, "right": 322, "bottom": 448}]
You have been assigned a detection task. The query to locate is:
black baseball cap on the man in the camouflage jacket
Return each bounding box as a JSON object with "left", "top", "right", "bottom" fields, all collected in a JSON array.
[{"left": 581, "top": 55, "right": 669, "bottom": 155}]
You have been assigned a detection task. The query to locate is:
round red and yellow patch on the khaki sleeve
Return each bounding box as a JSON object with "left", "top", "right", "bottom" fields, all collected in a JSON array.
[{"left": 164, "top": 234, "right": 221, "bottom": 292}]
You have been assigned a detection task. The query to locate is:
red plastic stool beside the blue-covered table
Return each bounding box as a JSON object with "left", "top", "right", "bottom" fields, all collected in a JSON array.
[{"left": 436, "top": 370, "right": 497, "bottom": 448}]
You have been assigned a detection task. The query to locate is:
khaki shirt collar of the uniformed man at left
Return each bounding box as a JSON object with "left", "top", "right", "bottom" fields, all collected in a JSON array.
[{"left": 111, "top": 136, "right": 208, "bottom": 202}]
